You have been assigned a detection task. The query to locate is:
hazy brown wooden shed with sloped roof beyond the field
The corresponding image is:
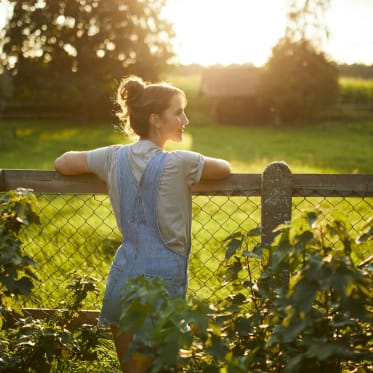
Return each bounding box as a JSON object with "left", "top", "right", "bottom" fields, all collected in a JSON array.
[{"left": 201, "top": 67, "right": 263, "bottom": 124}]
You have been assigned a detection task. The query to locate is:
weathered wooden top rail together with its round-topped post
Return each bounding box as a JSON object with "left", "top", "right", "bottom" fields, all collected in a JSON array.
[{"left": 0, "top": 162, "right": 373, "bottom": 243}]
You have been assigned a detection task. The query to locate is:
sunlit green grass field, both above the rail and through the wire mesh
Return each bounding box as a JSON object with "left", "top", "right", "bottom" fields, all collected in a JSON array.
[{"left": 0, "top": 75, "right": 373, "bottom": 308}]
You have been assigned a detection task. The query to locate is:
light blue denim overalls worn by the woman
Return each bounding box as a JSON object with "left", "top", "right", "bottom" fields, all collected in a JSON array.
[{"left": 100, "top": 146, "right": 190, "bottom": 326}]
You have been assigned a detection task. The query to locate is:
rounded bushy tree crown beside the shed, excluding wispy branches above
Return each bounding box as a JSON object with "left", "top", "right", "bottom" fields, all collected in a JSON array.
[{"left": 261, "top": 38, "right": 339, "bottom": 123}]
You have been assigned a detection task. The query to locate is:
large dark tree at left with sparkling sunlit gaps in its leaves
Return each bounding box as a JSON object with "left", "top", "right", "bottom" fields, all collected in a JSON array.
[{"left": 4, "top": 0, "right": 173, "bottom": 118}]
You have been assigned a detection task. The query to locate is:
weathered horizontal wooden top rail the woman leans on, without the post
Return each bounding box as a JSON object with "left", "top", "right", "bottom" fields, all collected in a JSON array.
[{"left": 0, "top": 162, "right": 373, "bottom": 197}]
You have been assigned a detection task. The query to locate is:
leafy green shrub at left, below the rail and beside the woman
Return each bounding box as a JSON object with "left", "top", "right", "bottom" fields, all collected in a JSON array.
[{"left": 0, "top": 189, "right": 117, "bottom": 373}]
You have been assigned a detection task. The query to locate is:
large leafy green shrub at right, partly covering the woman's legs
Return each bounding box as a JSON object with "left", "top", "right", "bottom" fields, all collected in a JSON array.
[{"left": 121, "top": 210, "right": 373, "bottom": 373}]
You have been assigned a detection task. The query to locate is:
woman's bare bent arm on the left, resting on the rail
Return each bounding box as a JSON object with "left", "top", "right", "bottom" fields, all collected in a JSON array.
[{"left": 54, "top": 151, "right": 92, "bottom": 175}]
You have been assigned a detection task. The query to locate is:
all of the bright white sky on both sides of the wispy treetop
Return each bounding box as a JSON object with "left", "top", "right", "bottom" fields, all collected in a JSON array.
[{"left": 0, "top": 0, "right": 373, "bottom": 66}]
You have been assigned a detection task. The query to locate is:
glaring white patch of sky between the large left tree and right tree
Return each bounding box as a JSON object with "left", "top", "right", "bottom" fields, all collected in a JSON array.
[{"left": 164, "top": 0, "right": 286, "bottom": 65}]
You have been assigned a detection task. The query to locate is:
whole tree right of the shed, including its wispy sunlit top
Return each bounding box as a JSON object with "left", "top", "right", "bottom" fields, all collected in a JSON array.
[{"left": 261, "top": 0, "right": 339, "bottom": 123}]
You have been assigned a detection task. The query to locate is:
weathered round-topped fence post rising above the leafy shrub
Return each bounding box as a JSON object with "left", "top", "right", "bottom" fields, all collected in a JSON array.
[{"left": 261, "top": 162, "right": 292, "bottom": 246}]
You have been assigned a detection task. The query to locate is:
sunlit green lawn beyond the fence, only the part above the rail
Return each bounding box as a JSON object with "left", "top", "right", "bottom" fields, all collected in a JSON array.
[{"left": 0, "top": 112, "right": 373, "bottom": 173}]
